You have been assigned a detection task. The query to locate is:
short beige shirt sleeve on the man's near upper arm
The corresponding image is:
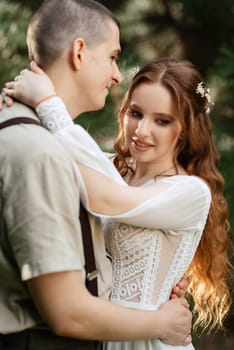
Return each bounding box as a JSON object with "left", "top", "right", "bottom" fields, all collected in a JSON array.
[{"left": 6, "top": 152, "right": 84, "bottom": 280}]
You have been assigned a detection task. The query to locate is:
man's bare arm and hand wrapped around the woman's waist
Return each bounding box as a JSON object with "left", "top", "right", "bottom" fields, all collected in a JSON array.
[{"left": 28, "top": 271, "right": 191, "bottom": 345}]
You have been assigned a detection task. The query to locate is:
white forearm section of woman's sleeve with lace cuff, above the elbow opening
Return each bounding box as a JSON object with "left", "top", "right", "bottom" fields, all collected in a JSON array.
[{"left": 36, "top": 96, "right": 127, "bottom": 186}]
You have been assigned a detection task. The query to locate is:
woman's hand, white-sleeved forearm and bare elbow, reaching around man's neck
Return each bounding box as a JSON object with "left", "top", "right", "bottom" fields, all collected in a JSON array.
[{"left": 5, "top": 62, "right": 170, "bottom": 215}]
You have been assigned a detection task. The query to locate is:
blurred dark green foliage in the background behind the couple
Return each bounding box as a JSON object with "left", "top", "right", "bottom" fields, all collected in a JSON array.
[{"left": 0, "top": 0, "right": 234, "bottom": 344}]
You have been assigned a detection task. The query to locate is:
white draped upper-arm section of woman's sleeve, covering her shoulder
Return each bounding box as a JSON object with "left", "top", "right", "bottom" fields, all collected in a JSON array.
[{"left": 106, "top": 176, "right": 211, "bottom": 234}]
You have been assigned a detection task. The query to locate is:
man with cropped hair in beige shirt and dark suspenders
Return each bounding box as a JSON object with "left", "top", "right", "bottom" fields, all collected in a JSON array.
[{"left": 0, "top": 0, "right": 191, "bottom": 350}]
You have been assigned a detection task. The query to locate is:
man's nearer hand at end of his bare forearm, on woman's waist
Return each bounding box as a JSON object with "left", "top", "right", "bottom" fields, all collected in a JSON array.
[{"left": 160, "top": 297, "right": 192, "bottom": 345}]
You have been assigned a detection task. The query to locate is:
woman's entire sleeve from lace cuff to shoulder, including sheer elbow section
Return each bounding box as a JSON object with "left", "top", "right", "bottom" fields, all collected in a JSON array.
[{"left": 37, "top": 97, "right": 210, "bottom": 231}]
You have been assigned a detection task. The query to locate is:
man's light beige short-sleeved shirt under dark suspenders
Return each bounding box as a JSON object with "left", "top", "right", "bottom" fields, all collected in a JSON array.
[{"left": 0, "top": 103, "right": 111, "bottom": 333}]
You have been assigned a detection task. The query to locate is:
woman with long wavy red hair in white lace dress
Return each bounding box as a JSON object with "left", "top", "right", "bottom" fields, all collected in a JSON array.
[{"left": 2, "top": 59, "right": 230, "bottom": 350}]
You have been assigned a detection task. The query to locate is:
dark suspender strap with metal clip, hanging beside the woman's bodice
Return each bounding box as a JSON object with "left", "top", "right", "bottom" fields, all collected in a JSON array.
[{"left": 80, "top": 202, "right": 98, "bottom": 296}]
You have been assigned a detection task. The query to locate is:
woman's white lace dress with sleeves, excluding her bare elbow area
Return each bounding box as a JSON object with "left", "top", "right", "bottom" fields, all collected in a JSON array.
[{"left": 37, "top": 98, "right": 211, "bottom": 350}]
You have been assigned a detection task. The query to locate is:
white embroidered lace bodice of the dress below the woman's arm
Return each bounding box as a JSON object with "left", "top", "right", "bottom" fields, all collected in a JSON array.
[{"left": 102, "top": 219, "right": 200, "bottom": 308}]
